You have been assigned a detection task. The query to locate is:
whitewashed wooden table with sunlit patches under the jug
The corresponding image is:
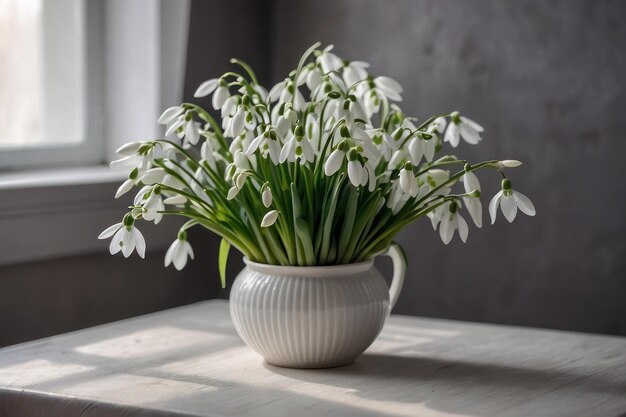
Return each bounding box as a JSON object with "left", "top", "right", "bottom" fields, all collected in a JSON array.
[{"left": 0, "top": 301, "right": 626, "bottom": 417}]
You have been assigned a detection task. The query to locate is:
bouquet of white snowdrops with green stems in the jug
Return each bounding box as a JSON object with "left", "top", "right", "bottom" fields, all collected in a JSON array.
[{"left": 100, "top": 44, "right": 535, "bottom": 281}]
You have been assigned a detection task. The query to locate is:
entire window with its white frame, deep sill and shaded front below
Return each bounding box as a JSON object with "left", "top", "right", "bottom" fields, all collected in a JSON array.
[{"left": 0, "top": 0, "right": 190, "bottom": 265}]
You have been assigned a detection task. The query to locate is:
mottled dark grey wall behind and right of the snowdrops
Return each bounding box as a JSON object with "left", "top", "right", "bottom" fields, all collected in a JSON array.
[{"left": 272, "top": 0, "right": 626, "bottom": 334}]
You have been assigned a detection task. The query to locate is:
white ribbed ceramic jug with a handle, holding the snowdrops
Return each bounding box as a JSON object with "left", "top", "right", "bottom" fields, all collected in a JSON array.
[{"left": 230, "top": 244, "right": 406, "bottom": 368}]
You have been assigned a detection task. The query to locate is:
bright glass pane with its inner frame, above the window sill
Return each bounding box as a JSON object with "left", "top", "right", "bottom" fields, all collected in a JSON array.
[{"left": 0, "top": 0, "right": 101, "bottom": 167}]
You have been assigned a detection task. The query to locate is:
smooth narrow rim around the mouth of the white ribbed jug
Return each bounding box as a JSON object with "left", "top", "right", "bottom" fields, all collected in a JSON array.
[{"left": 243, "top": 256, "right": 374, "bottom": 278}]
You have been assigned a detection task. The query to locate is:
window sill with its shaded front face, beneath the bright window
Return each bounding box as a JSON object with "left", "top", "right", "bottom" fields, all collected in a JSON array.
[{"left": 0, "top": 165, "right": 180, "bottom": 265}]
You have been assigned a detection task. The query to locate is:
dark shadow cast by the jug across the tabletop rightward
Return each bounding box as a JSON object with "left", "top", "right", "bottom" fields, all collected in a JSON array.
[{"left": 264, "top": 353, "right": 626, "bottom": 415}]
